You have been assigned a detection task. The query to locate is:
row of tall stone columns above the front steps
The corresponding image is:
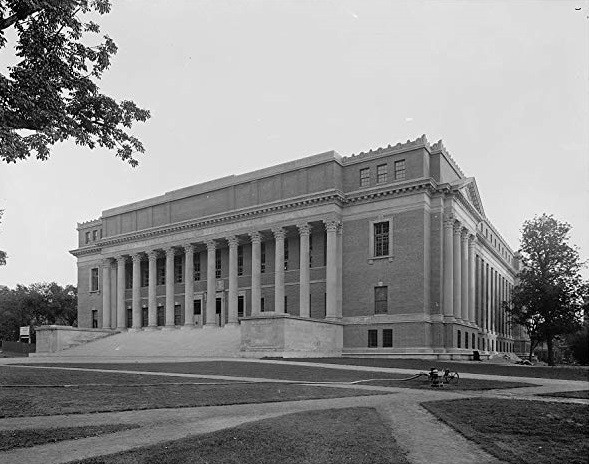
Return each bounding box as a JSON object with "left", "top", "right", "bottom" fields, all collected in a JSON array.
[{"left": 102, "top": 220, "right": 342, "bottom": 329}]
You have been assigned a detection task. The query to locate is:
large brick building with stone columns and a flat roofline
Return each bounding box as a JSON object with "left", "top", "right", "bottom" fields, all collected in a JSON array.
[{"left": 72, "top": 136, "right": 517, "bottom": 358}]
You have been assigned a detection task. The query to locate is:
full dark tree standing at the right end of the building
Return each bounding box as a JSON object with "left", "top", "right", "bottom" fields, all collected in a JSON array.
[{"left": 504, "top": 214, "right": 587, "bottom": 365}]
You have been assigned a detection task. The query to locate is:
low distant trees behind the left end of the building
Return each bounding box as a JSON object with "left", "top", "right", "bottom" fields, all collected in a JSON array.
[{"left": 0, "top": 282, "right": 78, "bottom": 340}]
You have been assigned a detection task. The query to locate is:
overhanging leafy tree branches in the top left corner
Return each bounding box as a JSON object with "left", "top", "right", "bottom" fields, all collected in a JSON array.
[{"left": 0, "top": 0, "right": 150, "bottom": 166}]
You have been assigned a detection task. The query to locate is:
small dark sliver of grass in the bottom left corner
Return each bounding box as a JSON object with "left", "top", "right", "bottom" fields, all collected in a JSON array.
[{"left": 0, "top": 424, "right": 139, "bottom": 451}]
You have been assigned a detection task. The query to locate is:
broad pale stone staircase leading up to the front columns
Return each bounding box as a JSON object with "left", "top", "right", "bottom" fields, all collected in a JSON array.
[{"left": 35, "top": 326, "right": 242, "bottom": 358}]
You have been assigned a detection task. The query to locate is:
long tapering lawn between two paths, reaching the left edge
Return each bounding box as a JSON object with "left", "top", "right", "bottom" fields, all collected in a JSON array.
[{"left": 0, "top": 383, "right": 383, "bottom": 417}]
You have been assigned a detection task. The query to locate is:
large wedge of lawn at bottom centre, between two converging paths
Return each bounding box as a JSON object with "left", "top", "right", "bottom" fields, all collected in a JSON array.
[{"left": 73, "top": 408, "right": 408, "bottom": 464}]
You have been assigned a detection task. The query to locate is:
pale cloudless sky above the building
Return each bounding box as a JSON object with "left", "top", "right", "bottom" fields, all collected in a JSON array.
[{"left": 0, "top": 0, "right": 589, "bottom": 287}]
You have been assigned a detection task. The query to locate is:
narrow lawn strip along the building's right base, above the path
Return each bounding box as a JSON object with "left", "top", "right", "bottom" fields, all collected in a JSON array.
[{"left": 285, "top": 358, "right": 589, "bottom": 381}]
